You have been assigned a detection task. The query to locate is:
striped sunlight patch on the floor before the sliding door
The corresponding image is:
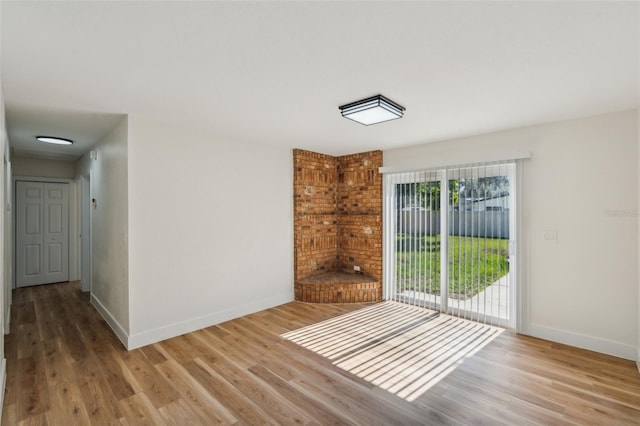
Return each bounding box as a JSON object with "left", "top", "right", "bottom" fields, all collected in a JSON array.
[{"left": 282, "top": 302, "right": 503, "bottom": 401}]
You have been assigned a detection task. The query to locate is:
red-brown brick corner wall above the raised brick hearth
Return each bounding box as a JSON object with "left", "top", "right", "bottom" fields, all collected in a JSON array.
[{"left": 293, "top": 149, "right": 382, "bottom": 282}]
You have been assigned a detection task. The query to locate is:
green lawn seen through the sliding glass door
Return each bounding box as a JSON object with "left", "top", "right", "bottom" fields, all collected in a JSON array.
[{"left": 396, "top": 234, "right": 509, "bottom": 299}]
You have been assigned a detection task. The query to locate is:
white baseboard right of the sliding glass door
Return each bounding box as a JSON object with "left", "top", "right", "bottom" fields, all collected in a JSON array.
[{"left": 523, "top": 324, "right": 640, "bottom": 362}]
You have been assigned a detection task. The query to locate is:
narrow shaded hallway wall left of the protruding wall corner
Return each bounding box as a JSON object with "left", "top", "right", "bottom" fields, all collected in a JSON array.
[{"left": 85, "top": 118, "right": 130, "bottom": 344}]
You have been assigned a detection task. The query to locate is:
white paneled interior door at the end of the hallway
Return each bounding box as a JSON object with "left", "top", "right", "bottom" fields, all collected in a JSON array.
[{"left": 16, "top": 181, "right": 69, "bottom": 287}]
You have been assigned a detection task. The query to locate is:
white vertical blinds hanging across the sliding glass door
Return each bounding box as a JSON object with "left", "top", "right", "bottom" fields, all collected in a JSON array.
[{"left": 384, "top": 162, "right": 515, "bottom": 326}]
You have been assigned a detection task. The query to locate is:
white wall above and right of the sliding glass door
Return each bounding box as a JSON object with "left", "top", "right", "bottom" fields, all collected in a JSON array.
[{"left": 384, "top": 110, "right": 640, "bottom": 359}]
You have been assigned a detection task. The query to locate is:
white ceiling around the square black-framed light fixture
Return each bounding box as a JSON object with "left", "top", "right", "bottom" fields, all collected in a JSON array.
[{"left": 0, "top": 1, "right": 640, "bottom": 159}]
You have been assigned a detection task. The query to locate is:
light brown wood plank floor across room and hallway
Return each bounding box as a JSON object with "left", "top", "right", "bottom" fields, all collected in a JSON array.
[{"left": 2, "top": 283, "right": 640, "bottom": 425}]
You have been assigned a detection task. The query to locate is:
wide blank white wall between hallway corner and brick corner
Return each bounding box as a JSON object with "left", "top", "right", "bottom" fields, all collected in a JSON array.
[{"left": 129, "top": 116, "right": 293, "bottom": 348}]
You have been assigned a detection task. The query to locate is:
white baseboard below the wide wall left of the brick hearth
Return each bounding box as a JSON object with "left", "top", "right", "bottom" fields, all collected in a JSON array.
[{"left": 126, "top": 292, "right": 293, "bottom": 350}]
